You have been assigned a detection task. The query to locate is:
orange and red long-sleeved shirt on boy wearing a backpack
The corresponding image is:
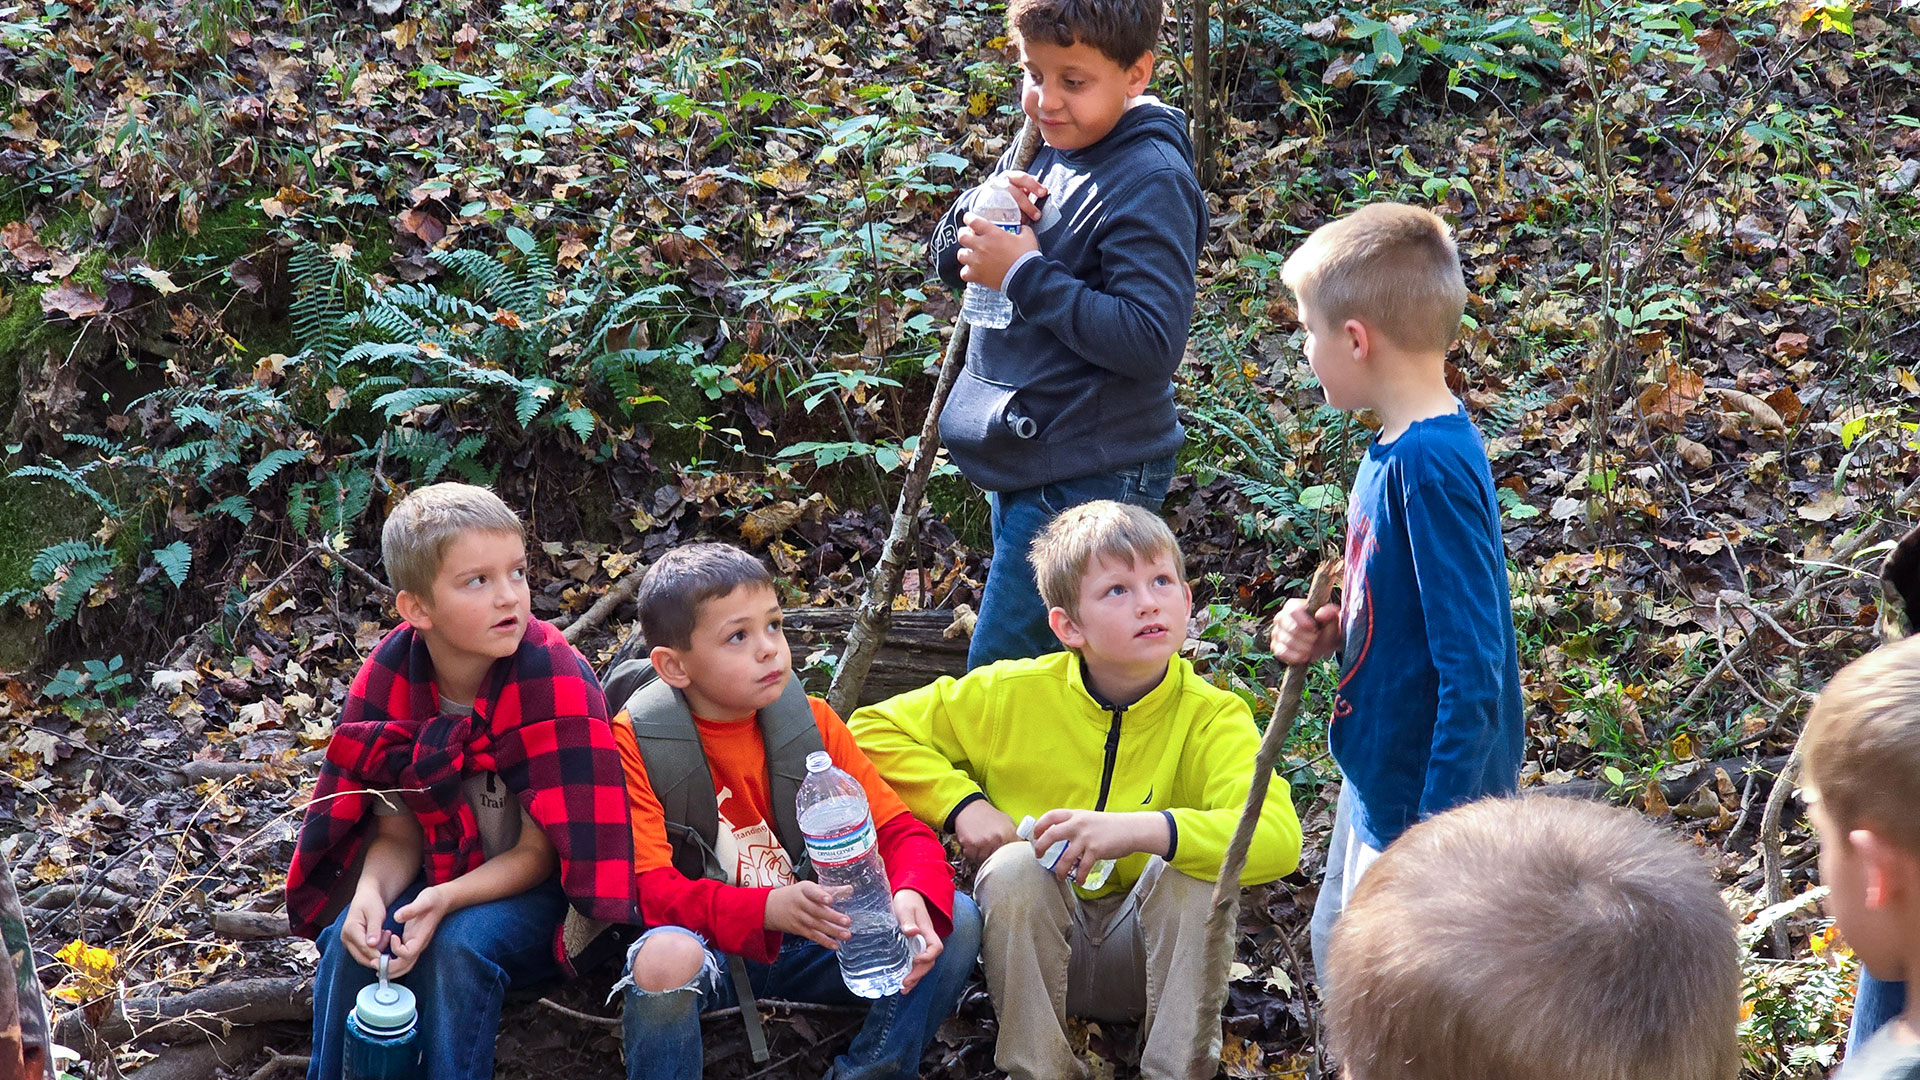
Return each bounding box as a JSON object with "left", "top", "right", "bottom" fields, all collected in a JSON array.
[{"left": 612, "top": 698, "right": 952, "bottom": 961}]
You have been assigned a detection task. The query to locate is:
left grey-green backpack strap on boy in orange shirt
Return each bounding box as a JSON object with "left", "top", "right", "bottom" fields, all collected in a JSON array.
[{"left": 607, "top": 659, "right": 726, "bottom": 880}]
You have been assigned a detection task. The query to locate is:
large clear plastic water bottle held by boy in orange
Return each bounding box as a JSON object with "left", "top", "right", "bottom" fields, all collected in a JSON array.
[{"left": 797, "top": 749, "right": 914, "bottom": 997}]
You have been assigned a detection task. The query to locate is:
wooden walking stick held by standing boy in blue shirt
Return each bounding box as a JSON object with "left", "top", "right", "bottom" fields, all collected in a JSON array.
[{"left": 1188, "top": 557, "right": 1340, "bottom": 1080}]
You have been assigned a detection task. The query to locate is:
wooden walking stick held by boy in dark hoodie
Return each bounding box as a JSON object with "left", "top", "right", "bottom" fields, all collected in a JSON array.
[{"left": 828, "top": 119, "right": 1041, "bottom": 717}]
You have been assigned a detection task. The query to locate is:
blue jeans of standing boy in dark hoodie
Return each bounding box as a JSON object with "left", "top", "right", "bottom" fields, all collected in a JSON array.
[{"left": 966, "top": 455, "right": 1173, "bottom": 671}]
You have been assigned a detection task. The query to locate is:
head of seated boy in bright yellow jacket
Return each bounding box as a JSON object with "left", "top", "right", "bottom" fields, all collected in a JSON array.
[{"left": 1027, "top": 500, "right": 1192, "bottom": 703}]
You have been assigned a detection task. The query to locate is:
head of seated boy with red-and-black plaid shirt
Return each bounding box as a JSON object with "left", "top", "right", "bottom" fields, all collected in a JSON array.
[{"left": 380, "top": 484, "right": 532, "bottom": 687}]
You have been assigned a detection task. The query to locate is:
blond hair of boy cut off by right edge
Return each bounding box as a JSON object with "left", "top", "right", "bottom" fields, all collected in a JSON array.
[{"left": 1801, "top": 638, "right": 1920, "bottom": 855}]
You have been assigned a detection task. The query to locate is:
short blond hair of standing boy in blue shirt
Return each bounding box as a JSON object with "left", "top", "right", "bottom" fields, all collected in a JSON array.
[{"left": 1281, "top": 202, "right": 1467, "bottom": 354}]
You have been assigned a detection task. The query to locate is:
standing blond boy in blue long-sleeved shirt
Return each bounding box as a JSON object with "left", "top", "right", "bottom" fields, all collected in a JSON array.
[{"left": 1271, "top": 204, "right": 1526, "bottom": 995}]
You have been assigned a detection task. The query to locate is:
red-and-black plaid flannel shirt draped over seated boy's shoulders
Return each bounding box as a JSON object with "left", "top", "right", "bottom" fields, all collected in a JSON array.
[{"left": 286, "top": 619, "right": 637, "bottom": 970}]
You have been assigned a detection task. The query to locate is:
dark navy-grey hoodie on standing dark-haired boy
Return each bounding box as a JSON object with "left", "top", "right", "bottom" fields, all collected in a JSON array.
[{"left": 933, "top": 98, "right": 1208, "bottom": 492}]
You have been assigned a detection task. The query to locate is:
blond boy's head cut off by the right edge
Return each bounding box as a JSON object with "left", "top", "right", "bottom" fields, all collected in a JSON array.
[{"left": 1801, "top": 638, "right": 1920, "bottom": 999}]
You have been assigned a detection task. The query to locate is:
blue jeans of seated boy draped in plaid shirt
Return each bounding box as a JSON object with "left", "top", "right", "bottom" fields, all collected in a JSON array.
[{"left": 307, "top": 874, "right": 566, "bottom": 1080}]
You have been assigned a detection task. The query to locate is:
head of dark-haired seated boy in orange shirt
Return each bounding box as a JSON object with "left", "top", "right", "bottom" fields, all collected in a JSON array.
[{"left": 636, "top": 544, "right": 793, "bottom": 721}]
